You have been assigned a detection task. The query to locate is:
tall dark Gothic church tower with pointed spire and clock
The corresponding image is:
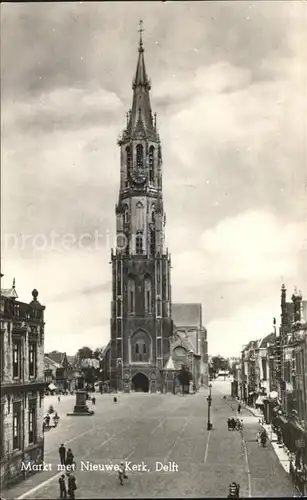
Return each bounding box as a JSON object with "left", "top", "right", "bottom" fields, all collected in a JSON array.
[{"left": 110, "top": 22, "right": 173, "bottom": 392}]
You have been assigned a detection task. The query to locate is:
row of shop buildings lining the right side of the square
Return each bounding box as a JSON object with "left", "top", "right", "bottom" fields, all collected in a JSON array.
[{"left": 232, "top": 285, "right": 307, "bottom": 492}]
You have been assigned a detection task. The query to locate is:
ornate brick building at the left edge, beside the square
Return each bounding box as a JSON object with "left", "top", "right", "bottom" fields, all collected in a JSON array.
[{"left": 0, "top": 276, "right": 45, "bottom": 486}]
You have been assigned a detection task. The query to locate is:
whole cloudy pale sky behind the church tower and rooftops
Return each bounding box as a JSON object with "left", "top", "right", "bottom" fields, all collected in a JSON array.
[{"left": 1, "top": 1, "right": 307, "bottom": 355}]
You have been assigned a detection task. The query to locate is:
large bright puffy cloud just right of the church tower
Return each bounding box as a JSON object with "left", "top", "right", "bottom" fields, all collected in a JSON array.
[{"left": 172, "top": 211, "right": 304, "bottom": 288}]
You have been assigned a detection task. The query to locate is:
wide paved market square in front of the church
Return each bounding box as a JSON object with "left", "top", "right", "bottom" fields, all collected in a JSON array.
[{"left": 3, "top": 383, "right": 293, "bottom": 499}]
